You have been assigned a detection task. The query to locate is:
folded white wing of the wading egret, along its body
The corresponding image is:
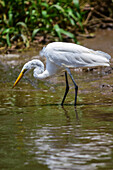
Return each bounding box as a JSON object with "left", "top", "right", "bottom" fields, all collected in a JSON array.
[{"left": 43, "top": 42, "right": 110, "bottom": 68}]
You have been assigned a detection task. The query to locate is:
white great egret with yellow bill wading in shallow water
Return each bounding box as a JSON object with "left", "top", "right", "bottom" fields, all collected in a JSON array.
[{"left": 13, "top": 42, "right": 111, "bottom": 106}]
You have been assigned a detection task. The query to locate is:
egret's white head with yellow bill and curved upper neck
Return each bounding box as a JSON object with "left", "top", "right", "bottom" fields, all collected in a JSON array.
[{"left": 13, "top": 59, "right": 44, "bottom": 88}]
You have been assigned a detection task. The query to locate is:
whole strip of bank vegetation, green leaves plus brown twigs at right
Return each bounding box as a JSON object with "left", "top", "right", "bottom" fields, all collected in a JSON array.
[{"left": 0, "top": 0, "right": 113, "bottom": 47}]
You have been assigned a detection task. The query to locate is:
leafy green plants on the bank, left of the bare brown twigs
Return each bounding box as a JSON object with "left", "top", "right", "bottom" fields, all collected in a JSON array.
[{"left": 0, "top": 0, "right": 83, "bottom": 47}]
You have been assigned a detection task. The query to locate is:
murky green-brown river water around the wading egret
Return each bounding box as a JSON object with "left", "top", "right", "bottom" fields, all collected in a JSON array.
[{"left": 0, "top": 31, "right": 113, "bottom": 170}]
